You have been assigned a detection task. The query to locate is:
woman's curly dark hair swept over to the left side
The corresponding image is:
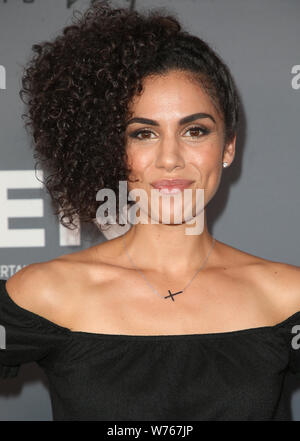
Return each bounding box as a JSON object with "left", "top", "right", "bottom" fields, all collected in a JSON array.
[{"left": 20, "top": 0, "right": 239, "bottom": 229}]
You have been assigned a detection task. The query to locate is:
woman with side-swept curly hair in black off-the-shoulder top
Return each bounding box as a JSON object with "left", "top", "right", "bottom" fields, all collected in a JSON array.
[{"left": 0, "top": 2, "right": 300, "bottom": 421}]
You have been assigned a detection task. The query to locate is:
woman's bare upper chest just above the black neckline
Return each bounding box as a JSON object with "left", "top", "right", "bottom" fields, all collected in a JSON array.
[{"left": 65, "top": 271, "right": 276, "bottom": 335}]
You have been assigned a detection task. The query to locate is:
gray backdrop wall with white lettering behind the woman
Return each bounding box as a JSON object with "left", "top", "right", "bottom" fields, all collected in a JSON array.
[{"left": 0, "top": 0, "right": 300, "bottom": 420}]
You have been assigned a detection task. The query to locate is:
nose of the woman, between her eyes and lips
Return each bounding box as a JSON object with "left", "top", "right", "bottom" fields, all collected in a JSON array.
[{"left": 155, "top": 135, "right": 185, "bottom": 172}]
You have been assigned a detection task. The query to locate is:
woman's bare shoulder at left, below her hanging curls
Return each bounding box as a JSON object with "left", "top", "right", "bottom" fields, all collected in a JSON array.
[{"left": 6, "top": 247, "right": 116, "bottom": 328}]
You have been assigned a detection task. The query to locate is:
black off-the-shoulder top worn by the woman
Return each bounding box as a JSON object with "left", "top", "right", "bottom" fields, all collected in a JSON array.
[{"left": 0, "top": 280, "right": 300, "bottom": 421}]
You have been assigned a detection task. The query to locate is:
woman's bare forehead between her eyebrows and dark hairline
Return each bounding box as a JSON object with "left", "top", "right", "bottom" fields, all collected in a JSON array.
[{"left": 130, "top": 71, "right": 218, "bottom": 119}]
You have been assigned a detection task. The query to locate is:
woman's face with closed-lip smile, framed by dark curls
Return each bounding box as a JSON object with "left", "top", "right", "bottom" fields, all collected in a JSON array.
[{"left": 126, "top": 71, "right": 235, "bottom": 223}]
